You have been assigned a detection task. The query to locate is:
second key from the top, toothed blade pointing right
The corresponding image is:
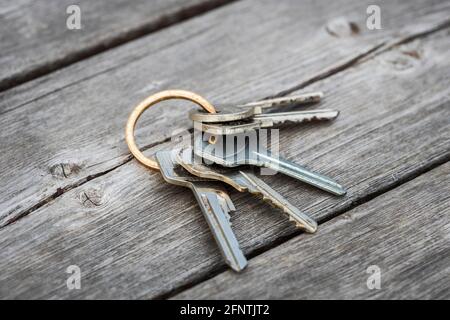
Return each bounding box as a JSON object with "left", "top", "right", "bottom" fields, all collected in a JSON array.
[{"left": 199, "top": 109, "right": 339, "bottom": 135}]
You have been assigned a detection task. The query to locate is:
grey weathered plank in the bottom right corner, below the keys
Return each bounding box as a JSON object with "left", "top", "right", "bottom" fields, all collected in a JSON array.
[{"left": 175, "top": 162, "right": 450, "bottom": 299}]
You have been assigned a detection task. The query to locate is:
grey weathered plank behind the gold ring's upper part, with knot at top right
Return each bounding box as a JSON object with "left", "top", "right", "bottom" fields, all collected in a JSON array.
[{"left": 0, "top": 0, "right": 450, "bottom": 226}]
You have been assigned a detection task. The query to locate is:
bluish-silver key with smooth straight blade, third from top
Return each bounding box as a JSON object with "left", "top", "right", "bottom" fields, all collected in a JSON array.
[{"left": 194, "top": 134, "right": 347, "bottom": 195}]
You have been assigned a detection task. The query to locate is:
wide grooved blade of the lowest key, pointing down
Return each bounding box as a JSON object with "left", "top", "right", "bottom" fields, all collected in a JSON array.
[{"left": 192, "top": 186, "right": 247, "bottom": 272}]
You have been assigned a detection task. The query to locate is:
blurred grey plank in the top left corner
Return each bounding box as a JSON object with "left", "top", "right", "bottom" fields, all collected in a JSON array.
[{"left": 0, "top": 0, "right": 232, "bottom": 90}]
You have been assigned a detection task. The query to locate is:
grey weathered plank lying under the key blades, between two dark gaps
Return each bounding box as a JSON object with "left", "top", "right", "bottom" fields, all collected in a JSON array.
[{"left": 0, "top": 29, "right": 450, "bottom": 298}]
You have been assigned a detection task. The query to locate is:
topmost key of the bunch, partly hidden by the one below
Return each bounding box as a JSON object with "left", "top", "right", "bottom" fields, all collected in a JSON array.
[{"left": 189, "top": 92, "right": 323, "bottom": 123}]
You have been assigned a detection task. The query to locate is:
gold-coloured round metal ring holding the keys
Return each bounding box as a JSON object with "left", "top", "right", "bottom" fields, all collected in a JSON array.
[{"left": 125, "top": 90, "right": 216, "bottom": 170}]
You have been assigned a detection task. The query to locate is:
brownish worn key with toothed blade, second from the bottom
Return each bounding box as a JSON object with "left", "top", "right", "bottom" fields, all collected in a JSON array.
[{"left": 177, "top": 147, "right": 317, "bottom": 233}]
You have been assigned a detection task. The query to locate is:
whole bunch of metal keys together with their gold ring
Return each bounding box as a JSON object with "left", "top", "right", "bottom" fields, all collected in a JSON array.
[{"left": 126, "top": 90, "right": 346, "bottom": 272}]
